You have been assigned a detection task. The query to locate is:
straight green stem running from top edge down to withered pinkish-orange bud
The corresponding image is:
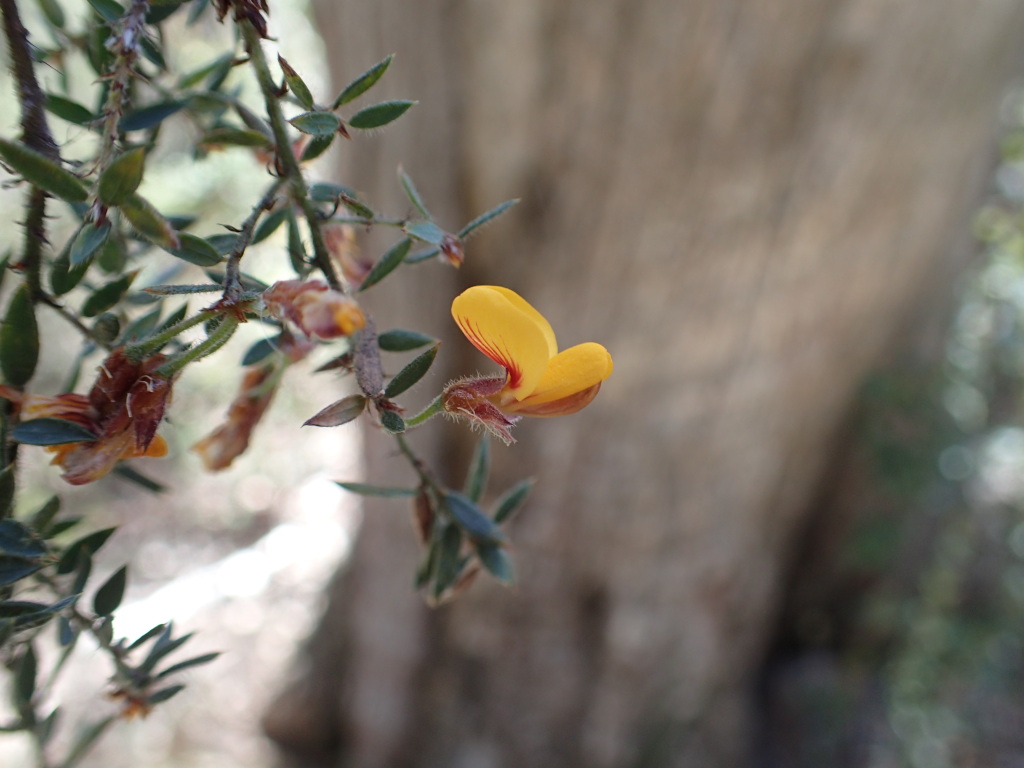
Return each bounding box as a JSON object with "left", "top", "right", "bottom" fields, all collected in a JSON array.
[{"left": 239, "top": 20, "right": 347, "bottom": 293}]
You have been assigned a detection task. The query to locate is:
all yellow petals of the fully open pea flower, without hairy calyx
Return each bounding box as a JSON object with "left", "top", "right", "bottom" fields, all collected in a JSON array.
[{"left": 452, "top": 286, "right": 612, "bottom": 416}]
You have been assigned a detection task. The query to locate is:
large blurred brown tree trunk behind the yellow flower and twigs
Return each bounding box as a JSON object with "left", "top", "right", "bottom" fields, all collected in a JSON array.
[{"left": 266, "top": 0, "right": 1024, "bottom": 768}]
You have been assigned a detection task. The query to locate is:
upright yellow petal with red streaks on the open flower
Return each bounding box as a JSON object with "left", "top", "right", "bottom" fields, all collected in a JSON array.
[{"left": 452, "top": 286, "right": 558, "bottom": 399}]
